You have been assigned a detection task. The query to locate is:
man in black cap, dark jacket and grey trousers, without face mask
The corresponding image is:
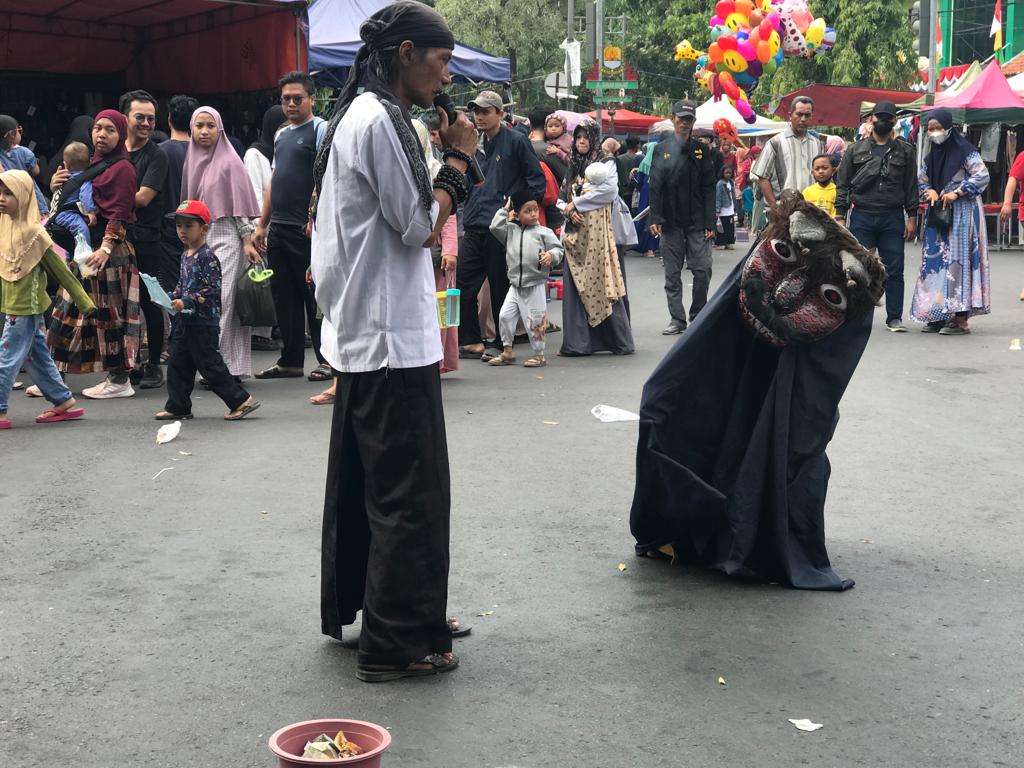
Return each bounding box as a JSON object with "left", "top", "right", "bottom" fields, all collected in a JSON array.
[{"left": 650, "top": 101, "right": 717, "bottom": 336}]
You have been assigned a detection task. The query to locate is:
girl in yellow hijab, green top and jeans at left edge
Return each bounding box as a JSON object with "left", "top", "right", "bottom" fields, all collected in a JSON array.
[{"left": 0, "top": 171, "right": 95, "bottom": 429}]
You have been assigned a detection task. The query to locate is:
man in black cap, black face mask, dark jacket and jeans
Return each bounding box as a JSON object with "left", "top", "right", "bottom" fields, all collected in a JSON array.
[{"left": 836, "top": 101, "right": 919, "bottom": 333}]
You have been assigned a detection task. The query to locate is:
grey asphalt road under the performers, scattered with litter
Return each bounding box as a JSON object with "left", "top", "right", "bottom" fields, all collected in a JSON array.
[{"left": 0, "top": 248, "right": 1024, "bottom": 768}]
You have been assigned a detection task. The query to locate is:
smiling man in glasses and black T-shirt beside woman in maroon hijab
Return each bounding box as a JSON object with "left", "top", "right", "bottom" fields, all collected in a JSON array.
[{"left": 119, "top": 90, "right": 167, "bottom": 389}]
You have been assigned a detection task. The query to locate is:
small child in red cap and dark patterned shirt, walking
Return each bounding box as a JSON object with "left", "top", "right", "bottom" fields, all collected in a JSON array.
[{"left": 157, "top": 200, "right": 259, "bottom": 421}]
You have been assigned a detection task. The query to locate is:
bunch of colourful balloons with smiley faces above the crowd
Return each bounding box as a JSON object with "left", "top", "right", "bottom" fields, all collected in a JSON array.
[{"left": 675, "top": 0, "right": 836, "bottom": 123}]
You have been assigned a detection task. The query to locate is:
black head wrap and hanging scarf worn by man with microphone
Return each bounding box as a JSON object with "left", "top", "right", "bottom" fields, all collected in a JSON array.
[{"left": 313, "top": 0, "right": 455, "bottom": 213}]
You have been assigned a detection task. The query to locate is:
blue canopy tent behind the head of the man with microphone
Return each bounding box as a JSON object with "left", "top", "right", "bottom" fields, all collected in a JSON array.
[{"left": 308, "top": 0, "right": 512, "bottom": 83}]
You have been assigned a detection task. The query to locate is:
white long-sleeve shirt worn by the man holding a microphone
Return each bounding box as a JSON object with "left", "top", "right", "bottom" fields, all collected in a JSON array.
[{"left": 312, "top": 93, "right": 441, "bottom": 373}]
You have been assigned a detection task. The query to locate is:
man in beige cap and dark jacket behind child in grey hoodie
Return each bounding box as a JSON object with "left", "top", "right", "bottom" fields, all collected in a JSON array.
[{"left": 457, "top": 91, "right": 546, "bottom": 359}]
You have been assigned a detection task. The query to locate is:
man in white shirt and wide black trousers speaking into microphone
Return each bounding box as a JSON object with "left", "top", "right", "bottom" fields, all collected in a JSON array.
[{"left": 312, "top": 0, "right": 476, "bottom": 682}]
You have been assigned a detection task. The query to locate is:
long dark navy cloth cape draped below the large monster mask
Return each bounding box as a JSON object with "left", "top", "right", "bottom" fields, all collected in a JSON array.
[{"left": 630, "top": 250, "right": 871, "bottom": 590}]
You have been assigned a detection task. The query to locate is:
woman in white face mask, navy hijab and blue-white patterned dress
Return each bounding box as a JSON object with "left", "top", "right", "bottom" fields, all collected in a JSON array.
[{"left": 910, "top": 108, "right": 991, "bottom": 336}]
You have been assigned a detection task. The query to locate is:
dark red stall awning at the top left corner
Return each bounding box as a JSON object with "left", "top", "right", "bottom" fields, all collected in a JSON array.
[{"left": 0, "top": 0, "right": 305, "bottom": 93}]
